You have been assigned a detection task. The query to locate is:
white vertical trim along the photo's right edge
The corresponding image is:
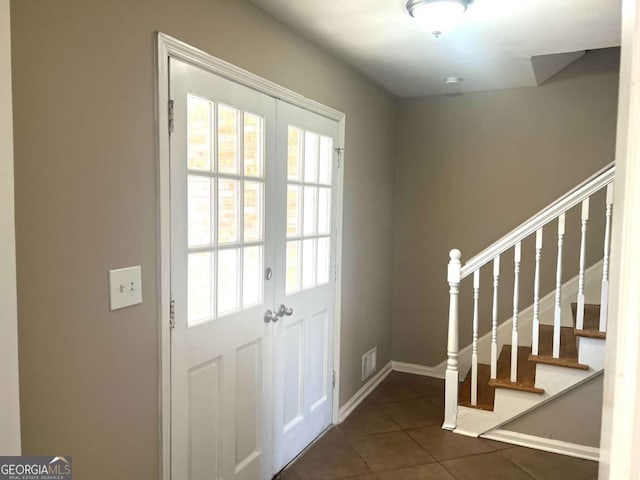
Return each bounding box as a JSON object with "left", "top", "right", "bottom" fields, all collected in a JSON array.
[{"left": 599, "top": 0, "right": 640, "bottom": 480}]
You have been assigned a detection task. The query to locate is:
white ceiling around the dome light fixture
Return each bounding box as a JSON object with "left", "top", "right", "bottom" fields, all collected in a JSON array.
[{"left": 252, "top": 0, "right": 621, "bottom": 97}]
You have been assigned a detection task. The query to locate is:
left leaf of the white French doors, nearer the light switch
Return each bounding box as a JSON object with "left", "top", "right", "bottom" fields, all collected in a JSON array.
[{"left": 170, "top": 60, "right": 276, "bottom": 480}]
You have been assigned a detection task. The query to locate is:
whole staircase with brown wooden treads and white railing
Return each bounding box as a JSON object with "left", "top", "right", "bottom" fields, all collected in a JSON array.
[{"left": 443, "top": 164, "right": 615, "bottom": 446}]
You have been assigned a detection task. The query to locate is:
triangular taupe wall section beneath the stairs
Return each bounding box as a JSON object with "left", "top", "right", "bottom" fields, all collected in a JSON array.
[{"left": 500, "top": 375, "right": 604, "bottom": 447}]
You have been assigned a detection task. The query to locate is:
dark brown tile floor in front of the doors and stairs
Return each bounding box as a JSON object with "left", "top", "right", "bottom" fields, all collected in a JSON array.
[{"left": 279, "top": 372, "right": 598, "bottom": 480}]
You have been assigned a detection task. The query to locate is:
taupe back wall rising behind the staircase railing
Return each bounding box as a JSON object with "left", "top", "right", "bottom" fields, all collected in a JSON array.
[{"left": 392, "top": 49, "right": 619, "bottom": 364}]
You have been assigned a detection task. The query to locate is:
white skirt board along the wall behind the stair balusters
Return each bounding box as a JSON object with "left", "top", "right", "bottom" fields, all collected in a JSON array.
[{"left": 432, "top": 260, "right": 602, "bottom": 381}]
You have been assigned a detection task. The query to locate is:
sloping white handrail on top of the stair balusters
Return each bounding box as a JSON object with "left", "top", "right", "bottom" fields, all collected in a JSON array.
[{"left": 460, "top": 161, "right": 616, "bottom": 280}]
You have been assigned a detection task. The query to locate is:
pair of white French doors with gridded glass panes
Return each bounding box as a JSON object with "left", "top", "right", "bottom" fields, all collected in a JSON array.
[{"left": 170, "top": 59, "right": 337, "bottom": 480}]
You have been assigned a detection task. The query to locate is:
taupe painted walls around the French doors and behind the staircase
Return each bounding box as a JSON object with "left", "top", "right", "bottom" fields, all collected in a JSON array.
[{"left": 11, "top": 0, "right": 618, "bottom": 474}]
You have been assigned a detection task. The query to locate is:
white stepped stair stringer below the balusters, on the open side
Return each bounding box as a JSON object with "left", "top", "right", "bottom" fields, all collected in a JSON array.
[{"left": 454, "top": 366, "right": 604, "bottom": 437}]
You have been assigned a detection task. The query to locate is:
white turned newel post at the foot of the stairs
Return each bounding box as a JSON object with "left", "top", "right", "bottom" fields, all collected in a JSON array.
[{"left": 442, "top": 249, "right": 462, "bottom": 430}]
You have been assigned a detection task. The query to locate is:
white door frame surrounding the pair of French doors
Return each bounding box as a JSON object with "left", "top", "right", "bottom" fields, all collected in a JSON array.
[{"left": 155, "top": 32, "right": 346, "bottom": 480}]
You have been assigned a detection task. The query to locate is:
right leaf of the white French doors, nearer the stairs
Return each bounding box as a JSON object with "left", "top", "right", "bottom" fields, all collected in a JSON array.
[{"left": 274, "top": 102, "right": 338, "bottom": 471}]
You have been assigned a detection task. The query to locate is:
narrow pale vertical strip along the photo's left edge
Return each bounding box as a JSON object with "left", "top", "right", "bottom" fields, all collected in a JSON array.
[{"left": 0, "top": 0, "right": 20, "bottom": 455}]
